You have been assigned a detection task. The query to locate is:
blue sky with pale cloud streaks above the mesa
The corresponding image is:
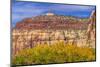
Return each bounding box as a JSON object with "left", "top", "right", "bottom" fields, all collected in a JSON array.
[{"left": 12, "top": 1, "right": 95, "bottom": 27}]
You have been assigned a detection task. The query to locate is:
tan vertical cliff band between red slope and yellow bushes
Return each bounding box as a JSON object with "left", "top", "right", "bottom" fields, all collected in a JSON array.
[{"left": 12, "top": 29, "right": 94, "bottom": 53}]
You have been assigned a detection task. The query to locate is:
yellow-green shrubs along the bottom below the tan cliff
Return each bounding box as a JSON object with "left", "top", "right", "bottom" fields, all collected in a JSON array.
[{"left": 12, "top": 42, "right": 95, "bottom": 65}]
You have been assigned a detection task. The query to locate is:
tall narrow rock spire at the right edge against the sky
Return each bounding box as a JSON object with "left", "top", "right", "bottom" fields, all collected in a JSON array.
[{"left": 87, "top": 11, "right": 96, "bottom": 40}]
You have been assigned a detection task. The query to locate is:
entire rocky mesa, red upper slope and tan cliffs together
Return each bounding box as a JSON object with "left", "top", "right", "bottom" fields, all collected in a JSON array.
[{"left": 12, "top": 13, "right": 95, "bottom": 54}]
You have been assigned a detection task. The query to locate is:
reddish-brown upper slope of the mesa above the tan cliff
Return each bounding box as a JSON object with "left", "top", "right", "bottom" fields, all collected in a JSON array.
[{"left": 15, "top": 15, "right": 88, "bottom": 30}]
